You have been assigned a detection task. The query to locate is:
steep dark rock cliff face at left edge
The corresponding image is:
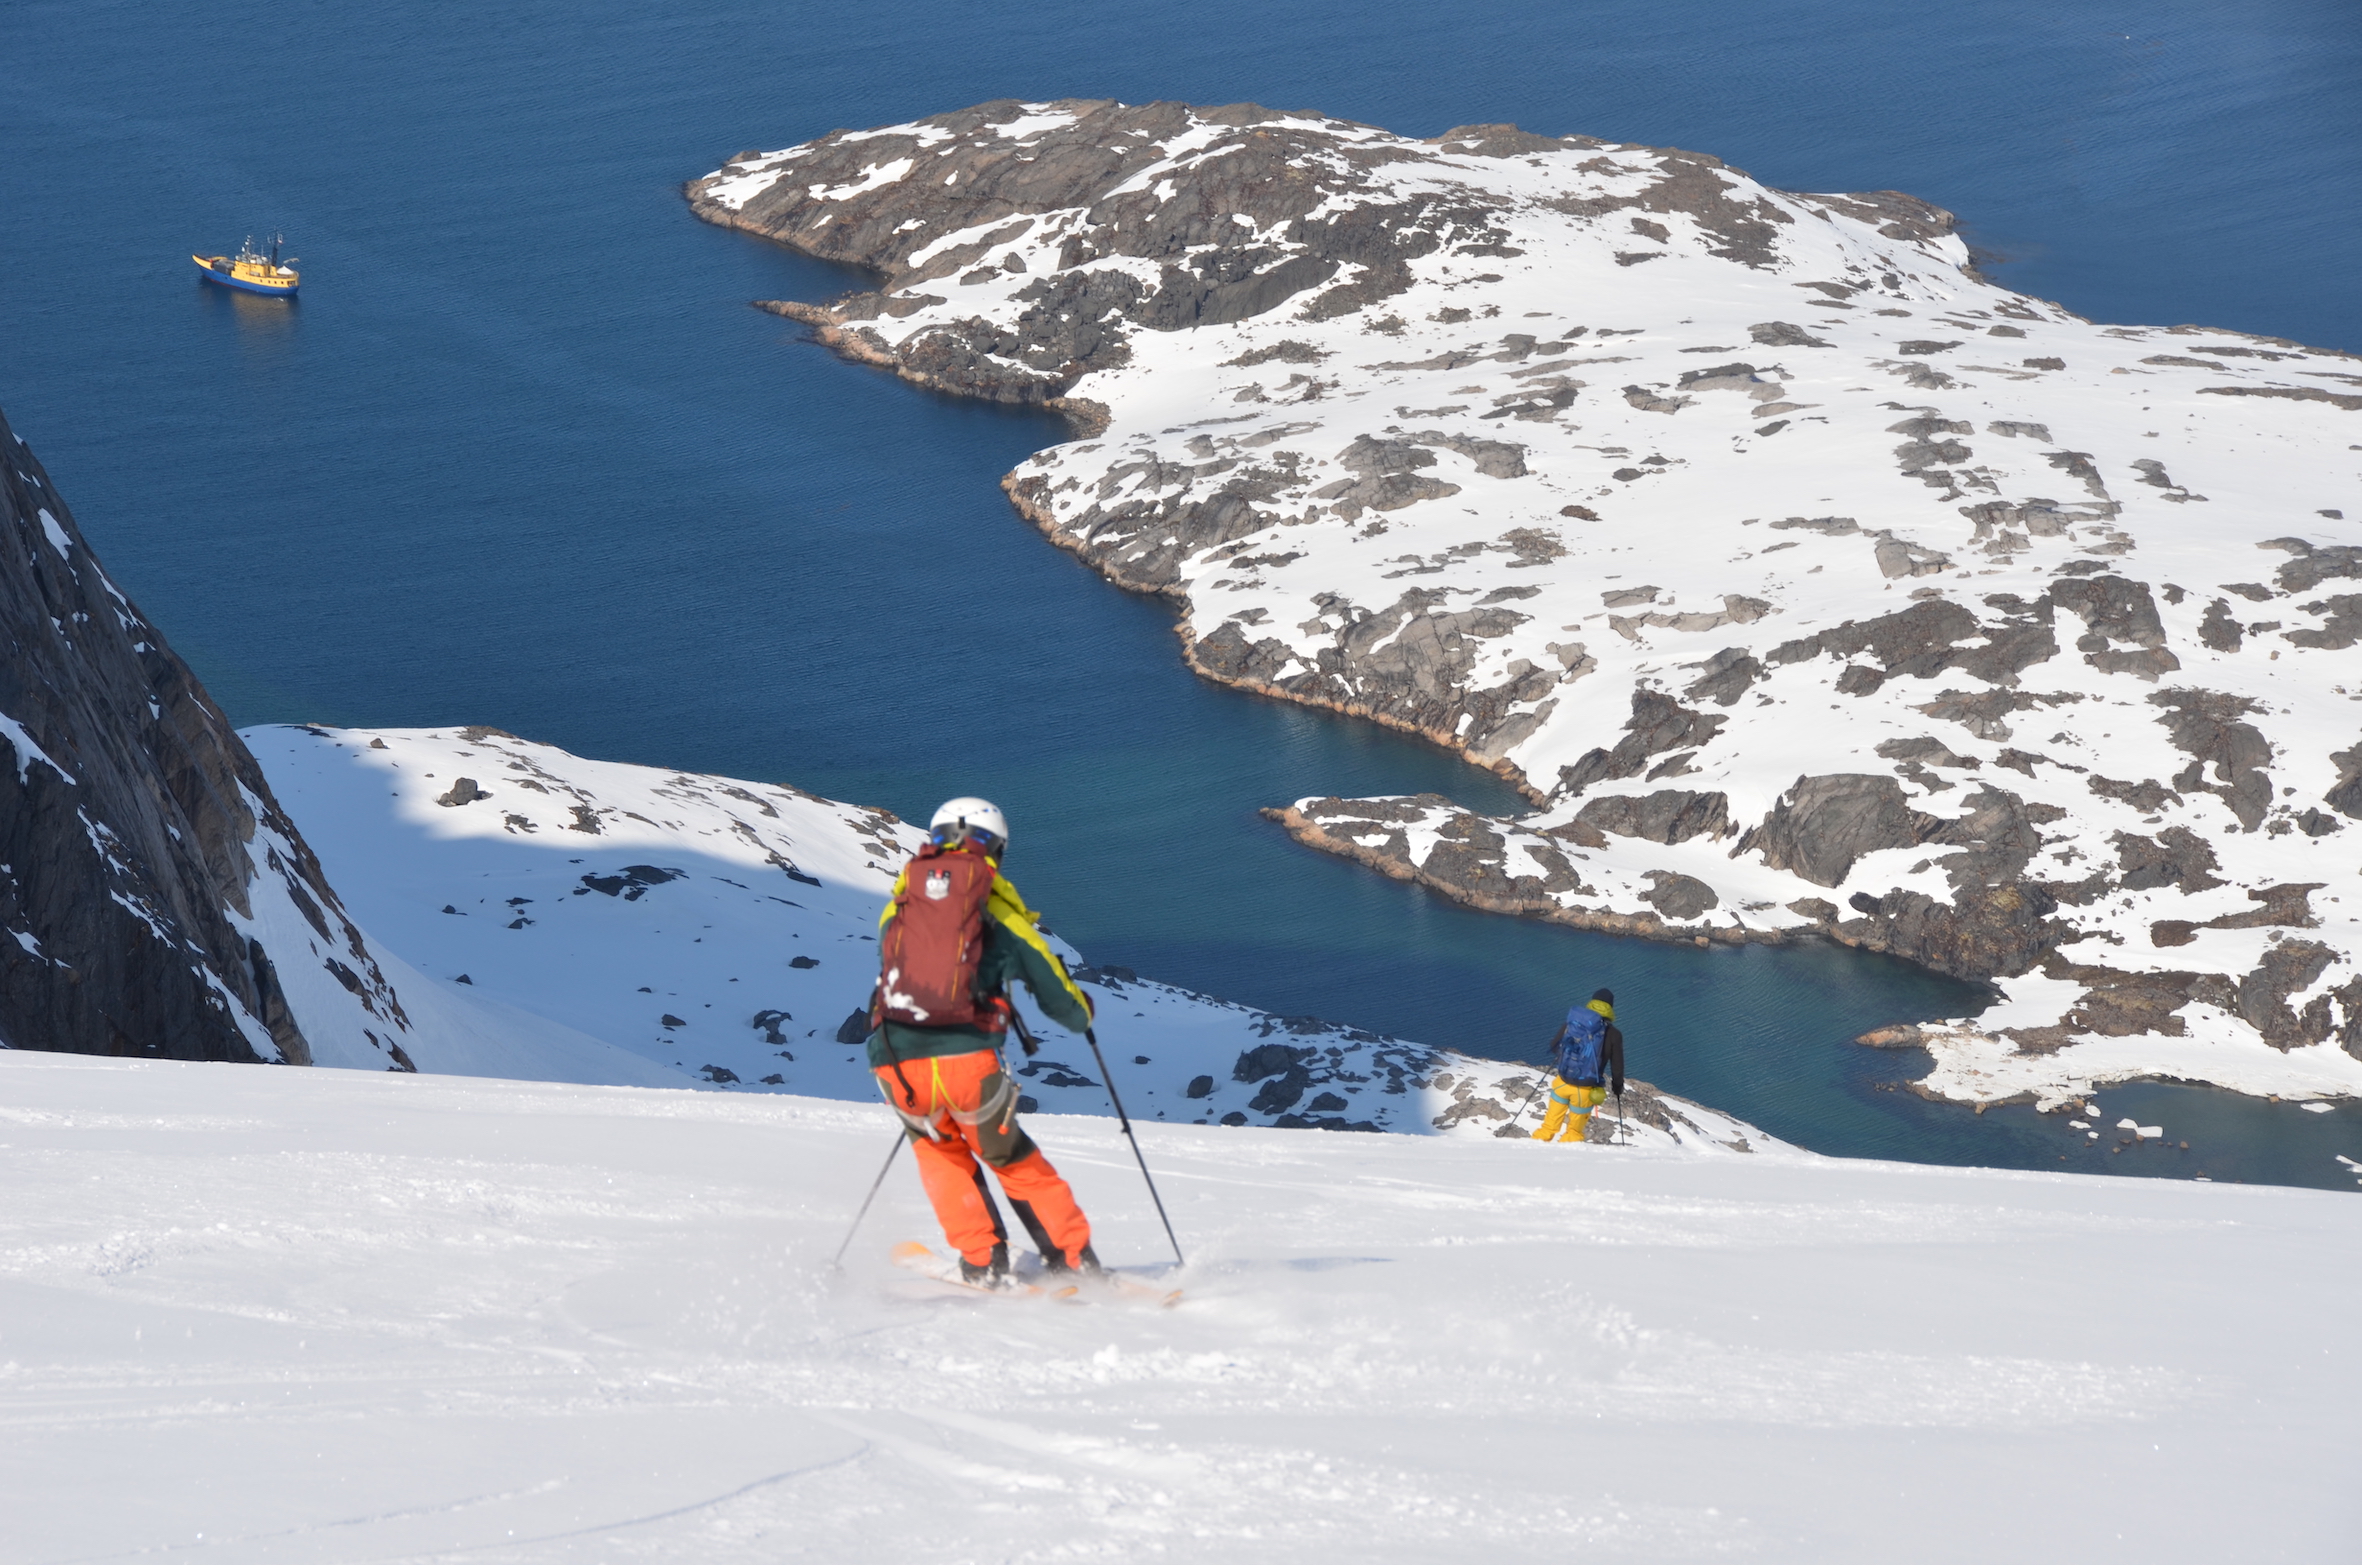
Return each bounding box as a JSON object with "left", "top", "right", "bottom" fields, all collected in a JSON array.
[{"left": 0, "top": 403, "right": 411, "bottom": 1069}]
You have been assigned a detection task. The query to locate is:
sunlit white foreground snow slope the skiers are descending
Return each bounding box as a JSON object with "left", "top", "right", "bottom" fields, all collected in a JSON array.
[{"left": 0, "top": 1053, "right": 2362, "bottom": 1565}]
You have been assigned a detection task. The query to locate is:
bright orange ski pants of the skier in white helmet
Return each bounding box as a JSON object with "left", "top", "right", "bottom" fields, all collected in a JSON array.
[{"left": 876, "top": 1048, "right": 1091, "bottom": 1265}]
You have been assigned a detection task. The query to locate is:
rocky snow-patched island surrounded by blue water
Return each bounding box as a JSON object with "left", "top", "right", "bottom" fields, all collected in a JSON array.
[{"left": 687, "top": 102, "right": 2362, "bottom": 1105}]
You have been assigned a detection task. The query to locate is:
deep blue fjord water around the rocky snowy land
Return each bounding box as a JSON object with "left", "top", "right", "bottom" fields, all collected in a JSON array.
[{"left": 0, "top": 0, "right": 2362, "bottom": 1185}]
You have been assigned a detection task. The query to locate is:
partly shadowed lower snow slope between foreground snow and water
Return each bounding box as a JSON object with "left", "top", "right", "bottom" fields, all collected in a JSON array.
[{"left": 241, "top": 727, "right": 1776, "bottom": 1152}]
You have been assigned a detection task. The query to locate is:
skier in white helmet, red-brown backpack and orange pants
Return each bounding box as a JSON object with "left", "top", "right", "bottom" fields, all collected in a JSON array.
[{"left": 869, "top": 798, "right": 1101, "bottom": 1286}]
